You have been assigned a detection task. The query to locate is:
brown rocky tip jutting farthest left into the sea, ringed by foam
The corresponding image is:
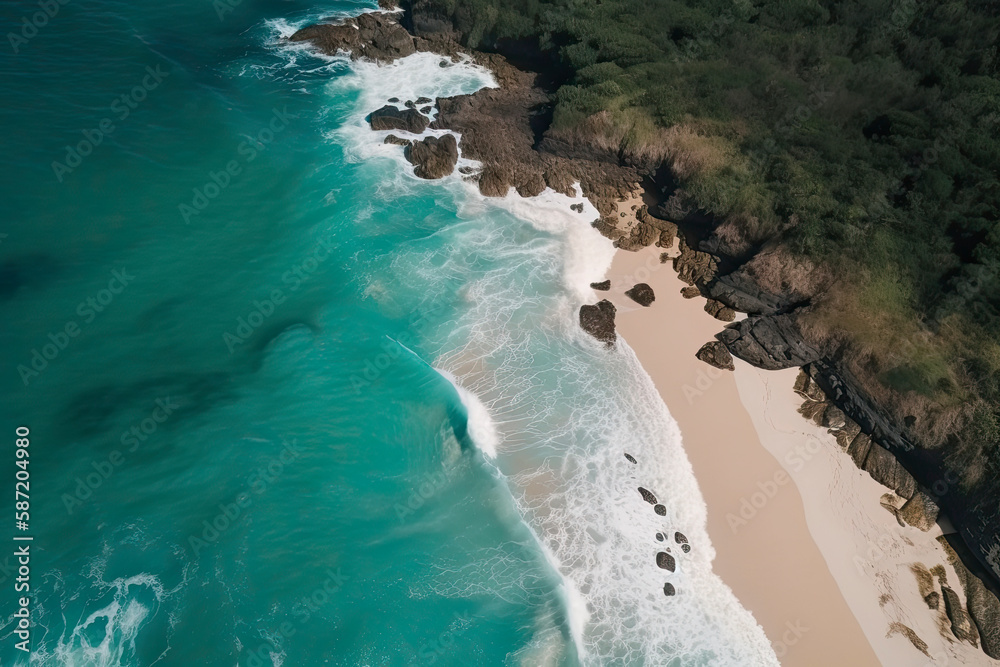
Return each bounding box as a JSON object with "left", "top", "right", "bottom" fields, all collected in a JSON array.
[{"left": 288, "top": 12, "right": 417, "bottom": 63}]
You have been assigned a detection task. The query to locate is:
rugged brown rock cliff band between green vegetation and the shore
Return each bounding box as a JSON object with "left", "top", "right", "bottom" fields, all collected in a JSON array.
[{"left": 291, "top": 0, "right": 1000, "bottom": 640}]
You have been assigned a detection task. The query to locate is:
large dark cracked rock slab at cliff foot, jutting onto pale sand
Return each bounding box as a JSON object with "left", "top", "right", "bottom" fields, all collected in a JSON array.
[{"left": 716, "top": 315, "right": 820, "bottom": 370}]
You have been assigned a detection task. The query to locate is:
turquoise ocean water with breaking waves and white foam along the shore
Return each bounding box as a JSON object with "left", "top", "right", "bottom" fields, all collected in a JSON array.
[{"left": 0, "top": 0, "right": 776, "bottom": 667}]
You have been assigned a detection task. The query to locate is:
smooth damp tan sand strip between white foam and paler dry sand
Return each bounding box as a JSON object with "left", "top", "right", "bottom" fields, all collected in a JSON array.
[{"left": 597, "top": 247, "right": 888, "bottom": 667}]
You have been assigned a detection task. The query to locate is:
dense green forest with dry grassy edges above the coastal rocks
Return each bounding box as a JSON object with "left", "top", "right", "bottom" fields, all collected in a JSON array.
[{"left": 422, "top": 0, "right": 1000, "bottom": 464}]
